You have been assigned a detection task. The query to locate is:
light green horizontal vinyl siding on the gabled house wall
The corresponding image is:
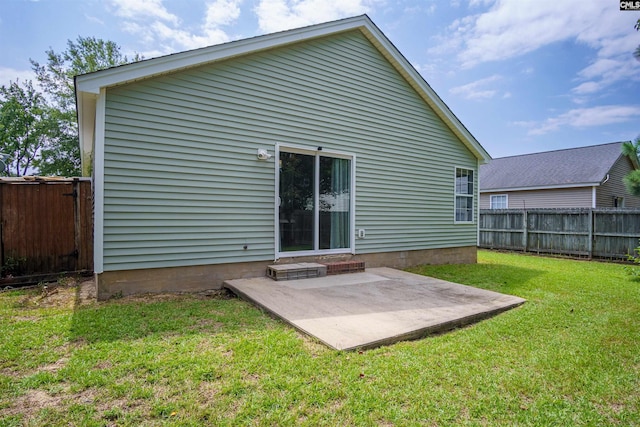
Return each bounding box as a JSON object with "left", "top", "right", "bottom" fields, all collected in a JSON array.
[{"left": 104, "top": 31, "right": 478, "bottom": 271}]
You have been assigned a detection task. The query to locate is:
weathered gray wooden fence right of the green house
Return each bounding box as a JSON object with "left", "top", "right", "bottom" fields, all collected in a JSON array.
[{"left": 478, "top": 209, "right": 640, "bottom": 259}]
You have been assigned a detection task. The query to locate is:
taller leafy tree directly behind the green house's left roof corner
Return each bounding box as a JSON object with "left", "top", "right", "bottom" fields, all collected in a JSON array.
[{"left": 30, "top": 37, "right": 142, "bottom": 176}]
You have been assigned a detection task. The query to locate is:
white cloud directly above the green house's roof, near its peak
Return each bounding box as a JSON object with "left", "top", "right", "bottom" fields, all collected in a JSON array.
[{"left": 254, "top": 0, "right": 384, "bottom": 33}]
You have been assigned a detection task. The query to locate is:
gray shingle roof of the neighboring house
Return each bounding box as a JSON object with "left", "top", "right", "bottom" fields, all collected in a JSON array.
[{"left": 480, "top": 142, "right": 623, "bottom": 191}]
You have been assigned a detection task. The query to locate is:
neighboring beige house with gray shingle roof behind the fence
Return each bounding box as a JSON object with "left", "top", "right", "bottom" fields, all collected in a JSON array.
[{"left": 480, "top": 142, "right": 640, "bottom": 209}]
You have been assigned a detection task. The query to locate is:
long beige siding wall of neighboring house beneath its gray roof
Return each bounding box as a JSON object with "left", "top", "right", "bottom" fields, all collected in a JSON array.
[{"left": 480, "top": 187, "right": 593, "bottom": 209}]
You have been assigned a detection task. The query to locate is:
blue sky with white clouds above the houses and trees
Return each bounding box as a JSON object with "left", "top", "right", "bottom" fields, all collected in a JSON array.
[{"left": 0, "top": 0, "right": 640, "bottom": 157}]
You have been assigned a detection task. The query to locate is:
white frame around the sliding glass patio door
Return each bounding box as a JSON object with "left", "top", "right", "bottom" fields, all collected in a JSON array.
[{"left": 274, "top": 143, "right": 356, "bottom": 261}]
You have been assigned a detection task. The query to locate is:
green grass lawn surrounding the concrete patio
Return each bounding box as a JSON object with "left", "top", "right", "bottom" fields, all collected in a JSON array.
[{"left": 0, "top": 252, "right": 640, "bottom": 427}]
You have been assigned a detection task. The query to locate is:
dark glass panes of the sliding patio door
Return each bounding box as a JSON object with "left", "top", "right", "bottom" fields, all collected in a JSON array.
[{"left": 278, "top": 151, "right": 352, "bottom": 252}]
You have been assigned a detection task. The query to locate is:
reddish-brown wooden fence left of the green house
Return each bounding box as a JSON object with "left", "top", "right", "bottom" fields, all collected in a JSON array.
[{"left": 0, "top": 178, "right": 93, "bottom": 283}]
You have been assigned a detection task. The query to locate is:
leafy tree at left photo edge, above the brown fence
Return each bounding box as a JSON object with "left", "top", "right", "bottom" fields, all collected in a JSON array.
[{"left": 0, "top": 80, "right": 58, "bottom": 176}]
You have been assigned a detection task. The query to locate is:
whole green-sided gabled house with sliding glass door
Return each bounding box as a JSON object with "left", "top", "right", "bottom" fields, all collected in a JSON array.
[{"left": 75, "top": 16, "right": 490, "bottom": 299}]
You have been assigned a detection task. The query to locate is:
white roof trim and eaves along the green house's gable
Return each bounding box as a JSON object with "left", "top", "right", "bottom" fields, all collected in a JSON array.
[{"left": 74, "top": 15, "right": 491, "bottom": 173}]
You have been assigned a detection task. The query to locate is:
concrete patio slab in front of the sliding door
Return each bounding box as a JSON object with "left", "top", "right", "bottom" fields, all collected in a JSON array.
[{"left": 225, "top": 268, "right": 525, "bottom": 350}]
